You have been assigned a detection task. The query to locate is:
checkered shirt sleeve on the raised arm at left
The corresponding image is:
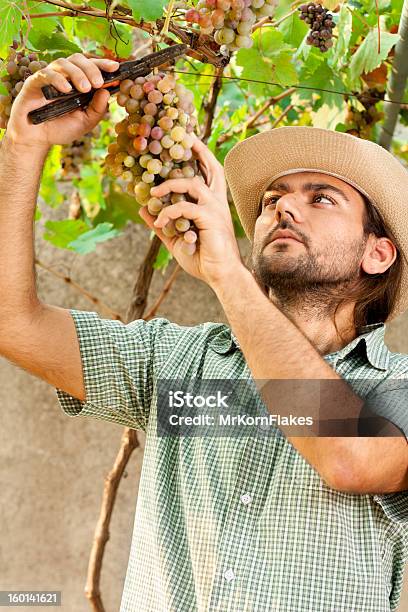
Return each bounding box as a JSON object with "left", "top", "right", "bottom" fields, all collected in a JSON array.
[{"left": 56, "top": 309, "right": 182, "bottom": 431}]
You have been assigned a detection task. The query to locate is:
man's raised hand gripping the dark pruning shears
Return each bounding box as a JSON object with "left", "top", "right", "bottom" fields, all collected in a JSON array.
[{"left": 6, "top": 53, "right": 119, "bottom": 149}]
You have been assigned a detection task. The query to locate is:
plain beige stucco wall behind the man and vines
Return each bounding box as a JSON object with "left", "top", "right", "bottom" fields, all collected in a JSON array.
[{"left": 0, "top": 211, "right": 408, "bottom": 612}]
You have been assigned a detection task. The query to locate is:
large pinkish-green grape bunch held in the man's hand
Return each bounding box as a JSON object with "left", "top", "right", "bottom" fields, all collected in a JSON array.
[{"left": 105, "top": 72, "right": 198, "bottom": 255}]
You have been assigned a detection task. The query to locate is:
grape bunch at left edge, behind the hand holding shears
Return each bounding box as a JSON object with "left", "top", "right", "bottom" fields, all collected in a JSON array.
[{"left": 0, "top": 41, "right": 47, "bottom": 128}]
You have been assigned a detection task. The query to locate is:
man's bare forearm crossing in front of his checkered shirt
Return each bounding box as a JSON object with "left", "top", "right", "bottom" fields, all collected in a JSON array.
[{"left": 213, "top": 266, "right": 404, "bottom": 492}]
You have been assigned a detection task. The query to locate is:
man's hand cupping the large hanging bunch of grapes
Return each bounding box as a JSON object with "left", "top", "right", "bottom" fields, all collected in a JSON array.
[{"left": 139, "top": 134, "right": 244, "bottom": 286}]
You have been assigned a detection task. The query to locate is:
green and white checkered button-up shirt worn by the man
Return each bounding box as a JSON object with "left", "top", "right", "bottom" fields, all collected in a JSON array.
[{"left": 57, "top": 310, "right": 408, "bottom": 612}]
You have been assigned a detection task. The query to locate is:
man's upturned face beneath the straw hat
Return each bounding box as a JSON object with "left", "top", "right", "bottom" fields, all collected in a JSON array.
[{"left": 251, "top": 172, "right": 366, "bottom": 302}]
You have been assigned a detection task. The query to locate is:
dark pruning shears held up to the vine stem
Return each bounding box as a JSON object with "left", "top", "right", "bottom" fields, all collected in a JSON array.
[{"left": 28, "top": 44, "right": 188, "bottom": 125}]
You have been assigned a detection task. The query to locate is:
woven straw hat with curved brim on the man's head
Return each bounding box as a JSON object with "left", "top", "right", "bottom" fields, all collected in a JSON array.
[{"left": 224, "top": 126, "right": 408, "bottom": 321}]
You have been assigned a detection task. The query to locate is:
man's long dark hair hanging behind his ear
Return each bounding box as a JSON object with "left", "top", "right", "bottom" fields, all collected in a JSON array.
[{"left": 333, "top": 195, "right": 403, "bottom": 337}]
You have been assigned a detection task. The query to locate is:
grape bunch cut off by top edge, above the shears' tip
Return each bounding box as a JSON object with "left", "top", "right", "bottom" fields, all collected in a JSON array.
[{"left": 185, "top": 0, "right": 279, "bottom": 52}]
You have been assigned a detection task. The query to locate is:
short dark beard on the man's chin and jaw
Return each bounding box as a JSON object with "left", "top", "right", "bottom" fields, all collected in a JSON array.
[{"left": 249, "top": 224, "right": 367, "bottom": 320}]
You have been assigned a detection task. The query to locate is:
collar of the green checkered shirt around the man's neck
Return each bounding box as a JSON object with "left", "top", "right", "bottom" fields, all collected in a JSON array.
[{"left": 211, "top": 323, "right": 390, "bottom": 370}]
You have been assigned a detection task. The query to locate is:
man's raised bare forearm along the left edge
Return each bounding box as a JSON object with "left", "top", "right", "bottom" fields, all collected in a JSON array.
[{"left": 0, "top": 134, "right": 48, "bottom": 323}]
